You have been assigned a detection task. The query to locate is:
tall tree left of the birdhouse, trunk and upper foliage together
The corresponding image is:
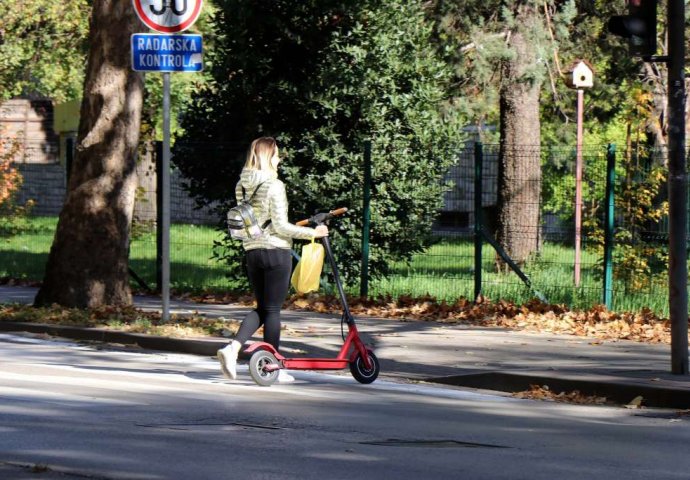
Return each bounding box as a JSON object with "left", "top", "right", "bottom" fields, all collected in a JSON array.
[{"left": 437, "top": 0, "right": 574, "bottom": 265}]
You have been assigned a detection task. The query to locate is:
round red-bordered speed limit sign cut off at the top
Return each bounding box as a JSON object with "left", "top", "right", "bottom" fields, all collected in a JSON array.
[{"left": 132, "top": 0, "right": 201, "bottom": 33}]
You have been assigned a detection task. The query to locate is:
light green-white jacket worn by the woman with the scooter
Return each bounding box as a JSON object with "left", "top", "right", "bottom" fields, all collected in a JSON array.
[{"left": 235, "top": 168, "right": 316, "bottom": 250}]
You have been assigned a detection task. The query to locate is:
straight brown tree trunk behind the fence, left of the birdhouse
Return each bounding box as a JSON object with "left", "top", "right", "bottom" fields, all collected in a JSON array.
[{"left": 497, "top": 7, "right": 542, "bottom": 268}]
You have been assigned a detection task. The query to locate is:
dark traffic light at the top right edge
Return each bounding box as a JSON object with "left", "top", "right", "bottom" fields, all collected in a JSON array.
[{"left": 608, "top": 0, "right": 657, "bottom": 57}]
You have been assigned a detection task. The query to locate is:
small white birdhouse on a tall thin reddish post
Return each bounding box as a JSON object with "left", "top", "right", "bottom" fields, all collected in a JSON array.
[{"left": 565, "top": 60, "right": 594, "bottom": 287}]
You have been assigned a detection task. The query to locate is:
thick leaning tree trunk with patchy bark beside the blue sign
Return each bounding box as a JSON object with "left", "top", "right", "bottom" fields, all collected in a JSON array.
[{"left": 35, "top": 0, "right": 143, "bottom": 308}]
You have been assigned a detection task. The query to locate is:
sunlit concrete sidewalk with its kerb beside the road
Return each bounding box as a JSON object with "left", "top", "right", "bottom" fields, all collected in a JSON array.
[{"left": 0, "top": 286, "right": 690, "bottom": 409}]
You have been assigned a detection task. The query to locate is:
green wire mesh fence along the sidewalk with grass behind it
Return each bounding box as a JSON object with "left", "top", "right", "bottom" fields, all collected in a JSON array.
[{"left": 0, "top": 139, "right": 668, "bottom": 314}]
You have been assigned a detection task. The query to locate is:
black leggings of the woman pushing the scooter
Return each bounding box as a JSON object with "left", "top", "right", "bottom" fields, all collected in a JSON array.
[{"left": 235, "top": 248, "right": 292, "bottom": 350}]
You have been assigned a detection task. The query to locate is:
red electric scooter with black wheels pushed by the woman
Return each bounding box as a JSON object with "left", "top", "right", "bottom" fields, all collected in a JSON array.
[{"left": 245, "top": 208, "right": 380, "bottom": 386}]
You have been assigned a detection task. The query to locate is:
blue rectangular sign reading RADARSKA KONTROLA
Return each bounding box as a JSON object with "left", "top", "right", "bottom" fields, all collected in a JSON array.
[{"left": 132, "top": 33, "right": 203, "bottom": 72}]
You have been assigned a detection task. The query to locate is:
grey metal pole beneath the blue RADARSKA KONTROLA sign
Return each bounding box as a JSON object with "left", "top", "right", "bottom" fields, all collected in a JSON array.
[{"left": 159, "top": 72, "right": 170, "bottom": 322}]
